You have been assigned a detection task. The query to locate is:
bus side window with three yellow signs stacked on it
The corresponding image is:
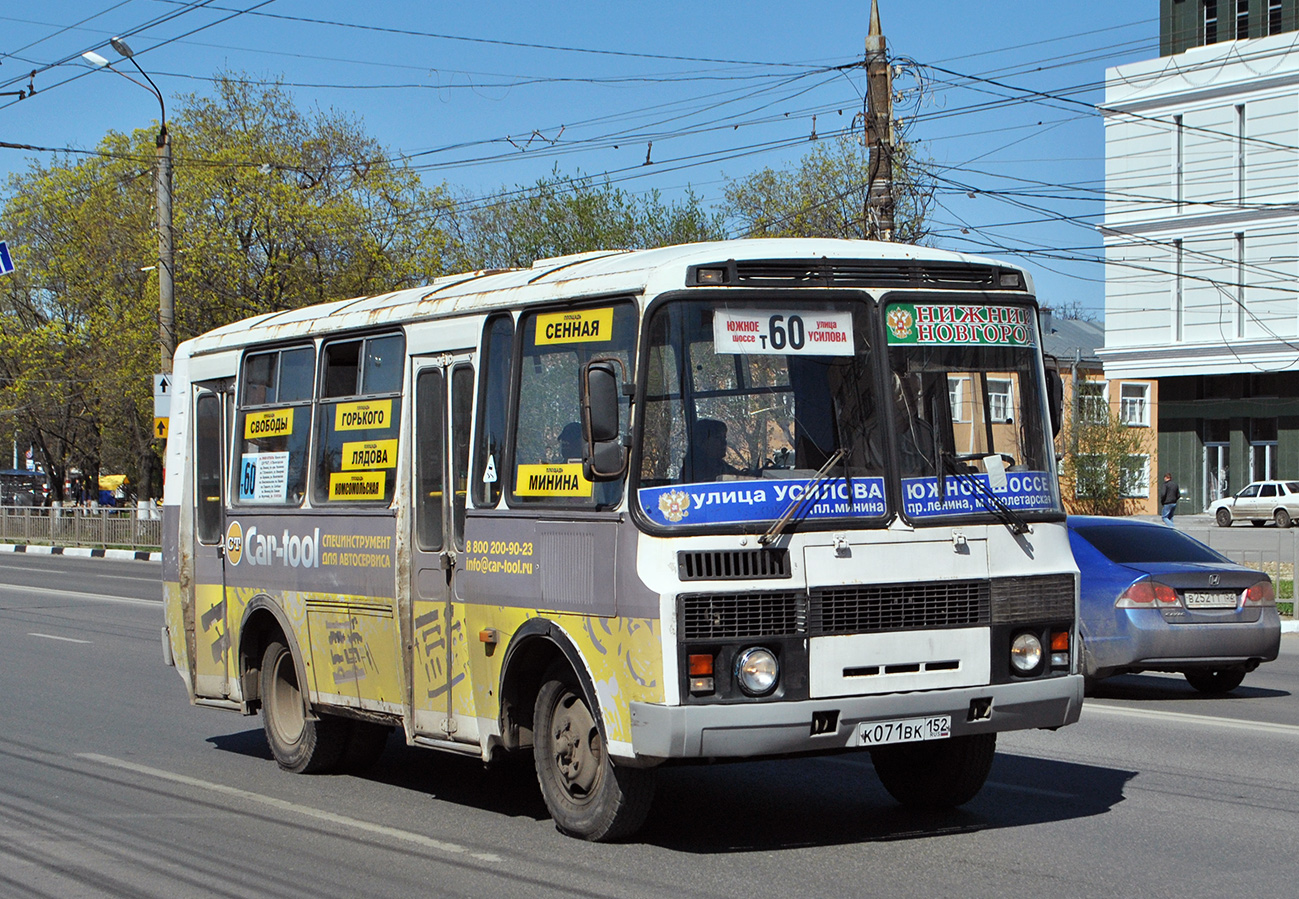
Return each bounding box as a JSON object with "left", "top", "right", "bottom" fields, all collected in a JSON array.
[{"left": 312, "top": 334, "right": 405, "bottom": 505}]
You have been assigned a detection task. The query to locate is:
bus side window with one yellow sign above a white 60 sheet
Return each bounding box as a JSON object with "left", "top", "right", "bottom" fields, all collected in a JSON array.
[{"left": 234, "top": 347, "right": 316, "bottom": 505}]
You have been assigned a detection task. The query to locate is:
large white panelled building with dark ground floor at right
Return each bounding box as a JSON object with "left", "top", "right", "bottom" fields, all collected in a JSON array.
[{"left": 1099, "top": 0, "right": 1299, "bottom": 511}]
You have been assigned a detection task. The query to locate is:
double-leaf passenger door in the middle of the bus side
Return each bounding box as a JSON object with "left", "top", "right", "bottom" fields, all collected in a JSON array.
[{"left": 410, "top": 351, "right": 477, "bottom": 739}]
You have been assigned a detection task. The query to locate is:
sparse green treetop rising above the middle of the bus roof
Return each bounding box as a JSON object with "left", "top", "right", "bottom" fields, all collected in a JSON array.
[{"left": 451, "top": 169, "right": 724, "bottom": 270}]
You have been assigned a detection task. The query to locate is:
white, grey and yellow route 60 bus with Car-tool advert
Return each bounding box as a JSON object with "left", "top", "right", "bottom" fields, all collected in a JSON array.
[{"left": 164, "top": 239, "right": 1082, "bottom": 839}]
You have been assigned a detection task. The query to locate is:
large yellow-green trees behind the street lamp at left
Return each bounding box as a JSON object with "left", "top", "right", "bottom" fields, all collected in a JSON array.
[{"left": 0, "top": 77, "right": 448, "bottom": 496}]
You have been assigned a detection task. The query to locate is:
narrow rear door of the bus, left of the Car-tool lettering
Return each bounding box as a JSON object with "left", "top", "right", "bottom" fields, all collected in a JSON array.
[{"left": 189, "top": 382, "right": 233, "bottom": 698}]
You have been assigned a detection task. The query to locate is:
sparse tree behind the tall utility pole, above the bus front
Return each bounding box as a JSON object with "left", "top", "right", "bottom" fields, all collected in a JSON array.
[{"left": 725, "top": 133, "right": 934, "bottom": 243}]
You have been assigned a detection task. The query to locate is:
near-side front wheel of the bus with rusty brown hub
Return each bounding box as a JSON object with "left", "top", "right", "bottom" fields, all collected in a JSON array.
[{"left": 533, "top": 663, "right": 655, "bottom": 842}]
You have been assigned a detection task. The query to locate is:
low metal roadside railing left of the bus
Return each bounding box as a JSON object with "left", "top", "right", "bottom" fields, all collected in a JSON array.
[{"left": 0, "top": 505, "right": 162, "bottom": 551}]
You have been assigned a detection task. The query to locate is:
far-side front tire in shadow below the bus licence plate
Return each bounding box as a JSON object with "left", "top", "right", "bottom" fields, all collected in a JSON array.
[{"left": 870, "top": 733, "right": 996, "bottom": 808}]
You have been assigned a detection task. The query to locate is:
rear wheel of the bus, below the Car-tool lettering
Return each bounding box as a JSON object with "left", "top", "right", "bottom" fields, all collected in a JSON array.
[{"left": 261, "top": 640, "right": 349, "bottom": 774}]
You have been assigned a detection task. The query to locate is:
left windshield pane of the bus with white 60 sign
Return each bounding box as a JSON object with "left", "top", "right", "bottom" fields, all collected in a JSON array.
[{"left": 639, "top": 298, "right": 887, "bottom": 525}]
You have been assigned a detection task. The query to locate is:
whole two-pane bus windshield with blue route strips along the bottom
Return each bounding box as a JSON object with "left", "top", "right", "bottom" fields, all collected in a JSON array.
[{"left": 638, "top": 295, "right": 1059, "bottom": 526}]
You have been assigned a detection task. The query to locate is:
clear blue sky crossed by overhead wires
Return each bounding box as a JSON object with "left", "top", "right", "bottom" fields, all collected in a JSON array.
[{"left": 0, "top": 0, "right": 1159, "bottom": 313}]
